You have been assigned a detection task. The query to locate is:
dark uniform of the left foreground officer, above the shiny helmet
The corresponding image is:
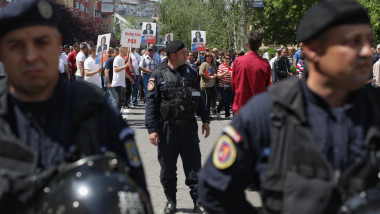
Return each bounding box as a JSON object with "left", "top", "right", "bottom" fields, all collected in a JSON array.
[{"left": 0, "top": 78, "right": 147, "bottom": 213}]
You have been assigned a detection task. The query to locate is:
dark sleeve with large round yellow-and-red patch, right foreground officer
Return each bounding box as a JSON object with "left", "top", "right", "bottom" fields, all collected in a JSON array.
[{"left": 198, "top": 93, "right": 270, "bottom": 214}]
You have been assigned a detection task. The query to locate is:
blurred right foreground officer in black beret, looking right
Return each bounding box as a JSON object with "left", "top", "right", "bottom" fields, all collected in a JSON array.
[{"left": 198, "top": 1, "right": 380, "bottom": 214}]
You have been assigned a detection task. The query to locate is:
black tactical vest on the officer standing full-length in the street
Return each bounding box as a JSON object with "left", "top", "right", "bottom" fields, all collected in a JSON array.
[{"left": 160, "top": 66, "right": 200, "bottom": 123}]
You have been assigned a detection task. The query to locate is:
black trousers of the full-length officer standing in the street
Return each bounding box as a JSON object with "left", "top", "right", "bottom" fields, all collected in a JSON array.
[{"left": 157, "top": 120, "right": 201, "bottom": 202}]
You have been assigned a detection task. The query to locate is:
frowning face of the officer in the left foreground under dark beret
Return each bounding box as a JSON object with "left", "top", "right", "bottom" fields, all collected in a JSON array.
[{"left": 0, "top": 26, "right": 62, "bottom": 95}]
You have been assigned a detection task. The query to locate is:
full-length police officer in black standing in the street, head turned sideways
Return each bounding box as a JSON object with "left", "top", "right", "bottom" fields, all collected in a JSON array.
[{"left": 145, "top": 40, "right": 210, "bottom": 213}]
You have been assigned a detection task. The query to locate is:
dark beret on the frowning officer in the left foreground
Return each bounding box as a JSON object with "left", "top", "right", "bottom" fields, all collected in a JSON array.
[{"left": 0, "top": 0, "right": 57, "bottom": 36}]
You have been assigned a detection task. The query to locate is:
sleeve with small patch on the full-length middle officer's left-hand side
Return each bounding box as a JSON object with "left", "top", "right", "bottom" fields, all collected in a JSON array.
[{"left": 145, "top": 72, "right": 162, "bottom": 134}]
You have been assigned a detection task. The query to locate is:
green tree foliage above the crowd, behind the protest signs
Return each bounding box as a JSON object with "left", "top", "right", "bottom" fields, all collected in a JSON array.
[{"left": 159, "top": 0, "right": 380, "bottom": 49}]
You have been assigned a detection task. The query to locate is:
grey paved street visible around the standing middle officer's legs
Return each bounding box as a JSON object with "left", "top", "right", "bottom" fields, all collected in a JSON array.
[{"left": 122, "top": 106, "right": 260, "bottom": 214}]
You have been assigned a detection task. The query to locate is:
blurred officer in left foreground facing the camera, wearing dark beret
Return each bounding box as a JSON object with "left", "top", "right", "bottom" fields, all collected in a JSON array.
[{"left": 0, "top": 0, "right": 148, "bottom": 213}]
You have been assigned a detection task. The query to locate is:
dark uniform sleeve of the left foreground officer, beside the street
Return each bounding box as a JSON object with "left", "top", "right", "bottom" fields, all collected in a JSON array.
[{"left": 102, "top": 100, "right": 149, "bottom": 197}]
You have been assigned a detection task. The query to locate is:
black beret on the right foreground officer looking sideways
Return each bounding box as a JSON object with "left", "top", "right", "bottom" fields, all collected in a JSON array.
[{"left": 297, "top": 0, "right": 370, "bottom": 42}]
